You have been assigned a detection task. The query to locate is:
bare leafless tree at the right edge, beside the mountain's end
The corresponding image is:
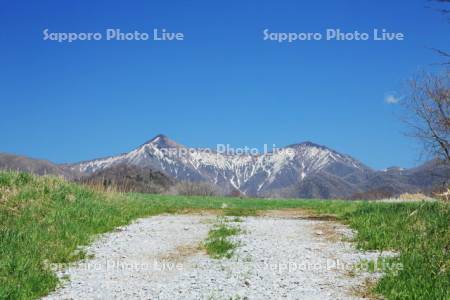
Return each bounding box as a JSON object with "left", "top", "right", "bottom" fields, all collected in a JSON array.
[{"left": 402, "top": 69, "right": 450, "bottom": 164}]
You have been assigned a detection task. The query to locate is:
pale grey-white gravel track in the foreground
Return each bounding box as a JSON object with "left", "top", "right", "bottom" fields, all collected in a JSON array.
[{"left": 45, "top": 215, "right": 390, "bottom": 300}]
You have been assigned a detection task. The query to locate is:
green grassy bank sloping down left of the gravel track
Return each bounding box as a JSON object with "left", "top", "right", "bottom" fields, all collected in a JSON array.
[{"left": 0, "top": 172, "right": 179, "bottom": 299}]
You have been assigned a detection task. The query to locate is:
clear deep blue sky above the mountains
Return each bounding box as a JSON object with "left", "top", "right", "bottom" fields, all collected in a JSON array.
[{"left": 0, "top": 0, "right": 450, "bottom": 168}]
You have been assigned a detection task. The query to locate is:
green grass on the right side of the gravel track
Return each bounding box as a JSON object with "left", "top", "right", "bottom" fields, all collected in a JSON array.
[{"left": 344, "top": 203, "right": 450, "bottom": 299}]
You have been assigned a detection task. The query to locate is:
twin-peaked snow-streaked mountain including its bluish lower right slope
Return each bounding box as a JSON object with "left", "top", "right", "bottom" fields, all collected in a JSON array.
[{"left": 70, "top": 135, "right": 373, "bottom": 197}]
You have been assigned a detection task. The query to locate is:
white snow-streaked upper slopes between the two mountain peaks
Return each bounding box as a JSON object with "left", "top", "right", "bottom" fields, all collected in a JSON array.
[{"left": 71, "top": 135, "right": 367, "bottom": 193}]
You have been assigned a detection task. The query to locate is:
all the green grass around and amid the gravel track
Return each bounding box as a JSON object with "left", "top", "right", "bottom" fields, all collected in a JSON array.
[{"left": 0, "top": 172, "right": 450, "bottom": 299}]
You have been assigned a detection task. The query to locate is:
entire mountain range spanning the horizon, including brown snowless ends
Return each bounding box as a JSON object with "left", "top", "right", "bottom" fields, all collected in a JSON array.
[{"left": 0, "top": 134, "right": 450, "bottom": 198}]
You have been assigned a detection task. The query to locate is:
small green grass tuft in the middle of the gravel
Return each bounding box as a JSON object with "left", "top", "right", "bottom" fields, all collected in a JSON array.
[{"left": 203, "top": 220, "right": 240, "bottom": 259}]
